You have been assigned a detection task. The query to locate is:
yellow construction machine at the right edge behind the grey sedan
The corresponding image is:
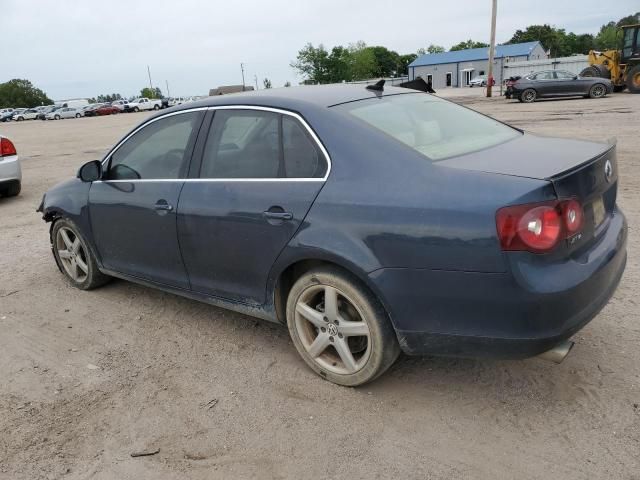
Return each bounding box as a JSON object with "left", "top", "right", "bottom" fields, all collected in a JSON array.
[{"left": 580, "top": 24, "right": 640, "bottom": 93}]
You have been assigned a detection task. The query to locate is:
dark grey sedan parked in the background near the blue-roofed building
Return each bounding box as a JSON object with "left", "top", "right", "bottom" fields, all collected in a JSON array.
[{"left": 511, "top": 70, "right": 613, "bottom": 103}]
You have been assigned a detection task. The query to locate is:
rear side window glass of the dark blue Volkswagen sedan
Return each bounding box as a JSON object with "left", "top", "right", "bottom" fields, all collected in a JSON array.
[{"left": 200, "top": 109, "right": 327, "bottom": 179}]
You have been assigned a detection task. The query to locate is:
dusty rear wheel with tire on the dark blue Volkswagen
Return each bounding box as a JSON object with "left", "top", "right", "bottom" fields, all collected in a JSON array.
[{"left": 286, "top": 267, "right": 400, "bottom": 387}]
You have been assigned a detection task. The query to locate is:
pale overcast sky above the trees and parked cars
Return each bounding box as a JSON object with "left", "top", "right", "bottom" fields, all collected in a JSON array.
[{"left": 0, "top": 0, "right": 640, "bottom": 100}]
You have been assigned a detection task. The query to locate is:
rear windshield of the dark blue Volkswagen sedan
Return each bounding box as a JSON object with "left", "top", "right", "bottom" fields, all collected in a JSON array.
[{"left": 334, "top": 93, "right": 521, "bottom": 161}]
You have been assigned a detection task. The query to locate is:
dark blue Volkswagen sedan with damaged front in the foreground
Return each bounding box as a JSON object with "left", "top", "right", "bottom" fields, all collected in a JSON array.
[{"left": 39, "top": 86, "right": 627, "bottom": 385}]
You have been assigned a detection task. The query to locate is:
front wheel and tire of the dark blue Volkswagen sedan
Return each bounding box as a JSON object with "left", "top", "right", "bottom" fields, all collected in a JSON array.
[{"left": 51, "top": 218, "right": 110, "bottom": 290}]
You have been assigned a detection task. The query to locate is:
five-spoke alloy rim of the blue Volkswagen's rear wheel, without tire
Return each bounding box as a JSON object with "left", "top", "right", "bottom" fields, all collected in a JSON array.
[{"left": 295, "top": 285, "right": 372, "bottom": 374}]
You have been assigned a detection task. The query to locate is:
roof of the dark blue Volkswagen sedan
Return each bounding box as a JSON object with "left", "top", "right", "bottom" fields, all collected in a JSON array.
[{"left": 166, "top": 84, "right": 422, "bottom": 115}]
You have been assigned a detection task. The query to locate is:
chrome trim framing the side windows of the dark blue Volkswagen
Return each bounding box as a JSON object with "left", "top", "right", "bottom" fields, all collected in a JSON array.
[{"left": 99, "top": 105, "right": 331, "bottom": 183}]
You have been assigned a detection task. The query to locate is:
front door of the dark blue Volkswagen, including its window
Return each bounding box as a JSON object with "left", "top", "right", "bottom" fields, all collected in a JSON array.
[{"left": 89, "top": 109, "right": 204, "bottom": 289}]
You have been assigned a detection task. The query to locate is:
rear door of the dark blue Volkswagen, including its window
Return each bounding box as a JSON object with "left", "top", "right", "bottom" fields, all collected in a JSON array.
[{"left": 178, "top": 107, "right": 330, "bottom": 304}]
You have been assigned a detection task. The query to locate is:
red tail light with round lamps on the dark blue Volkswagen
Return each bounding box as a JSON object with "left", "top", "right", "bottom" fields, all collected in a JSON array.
[{"left": 496, "top": 199, "right": 584, "bottom": 253}]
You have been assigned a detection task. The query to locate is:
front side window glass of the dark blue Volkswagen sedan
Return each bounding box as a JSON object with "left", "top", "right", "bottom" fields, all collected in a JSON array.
[{"left": 106, "top": 112, "right": 201, "bottom": 180}]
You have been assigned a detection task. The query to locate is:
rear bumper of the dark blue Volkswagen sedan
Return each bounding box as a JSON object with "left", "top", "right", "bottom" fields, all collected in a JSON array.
[{"left": 371, "top": 211, "right": 627, "bottom": 358}]
